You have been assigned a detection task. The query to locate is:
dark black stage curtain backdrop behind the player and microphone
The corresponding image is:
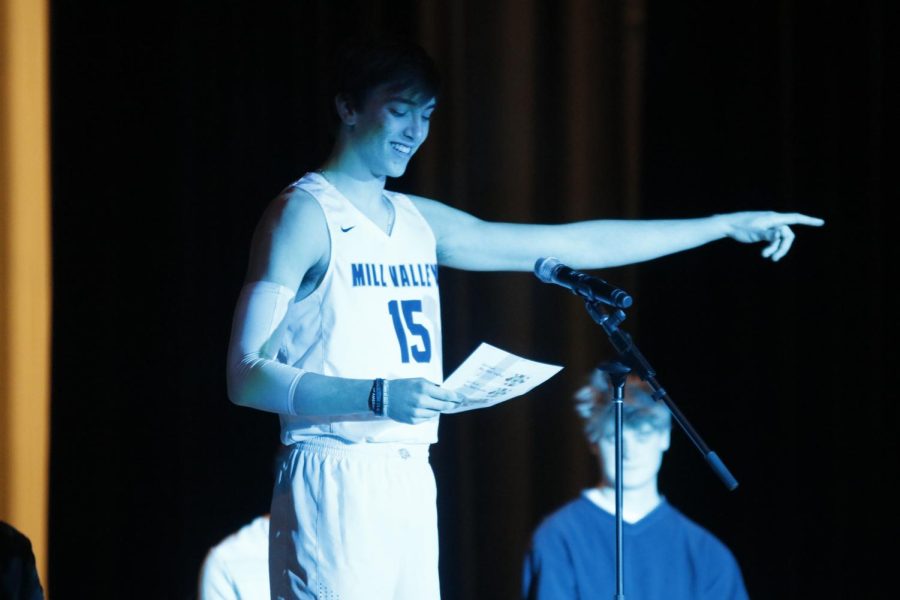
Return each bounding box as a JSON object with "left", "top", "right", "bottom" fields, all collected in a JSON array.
[{"left": 48, "top": 0, "right": 900, "bottom": 599}]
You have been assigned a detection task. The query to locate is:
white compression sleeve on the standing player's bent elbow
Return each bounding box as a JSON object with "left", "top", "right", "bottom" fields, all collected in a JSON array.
[{"left": 227, "top": 281, "right": 305, "bottom": 415}]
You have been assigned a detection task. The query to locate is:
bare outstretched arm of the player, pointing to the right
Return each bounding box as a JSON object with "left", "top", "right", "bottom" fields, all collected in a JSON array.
[{"left": 414, "top": 198, "right": 824, "bottom": 271}]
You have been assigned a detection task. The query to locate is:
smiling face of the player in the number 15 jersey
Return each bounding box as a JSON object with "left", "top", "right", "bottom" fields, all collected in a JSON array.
[{"left": 348, "top": 86, "right": 436, "bottom": 177}]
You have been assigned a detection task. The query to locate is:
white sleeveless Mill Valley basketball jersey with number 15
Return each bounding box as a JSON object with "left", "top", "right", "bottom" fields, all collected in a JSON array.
[{"left": 278, "top": 173, "right": 443, "bottom": 444}]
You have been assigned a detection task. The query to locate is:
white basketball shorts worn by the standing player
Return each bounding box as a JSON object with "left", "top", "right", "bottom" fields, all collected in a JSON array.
[{"left": 269, "top": 438, "right": 440, "bottom": 600}]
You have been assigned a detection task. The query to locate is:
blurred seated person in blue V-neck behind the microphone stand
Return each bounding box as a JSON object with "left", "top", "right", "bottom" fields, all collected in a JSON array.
[{"left": 522, "top": 371, "right": 748, "bottom": 600}]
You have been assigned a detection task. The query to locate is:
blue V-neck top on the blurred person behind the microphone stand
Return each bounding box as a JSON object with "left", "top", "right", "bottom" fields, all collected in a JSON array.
[{"left": 522, "top": 497, "right": 747, "bottom": 600}]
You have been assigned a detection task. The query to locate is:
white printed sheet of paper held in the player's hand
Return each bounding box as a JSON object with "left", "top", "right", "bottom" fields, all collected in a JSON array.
[{"left": 443, "top": 342, "right": 562, "bottom": 413}]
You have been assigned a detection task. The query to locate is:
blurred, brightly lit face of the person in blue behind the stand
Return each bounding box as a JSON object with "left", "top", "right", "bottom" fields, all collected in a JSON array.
[{"left": 598, "top": 419, "right": 670, "bottom": 490}]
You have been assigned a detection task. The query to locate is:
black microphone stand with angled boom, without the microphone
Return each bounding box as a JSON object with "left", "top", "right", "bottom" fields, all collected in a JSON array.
[{"left": 585, "top": 300, "right": 738, "bottom": 600}]
